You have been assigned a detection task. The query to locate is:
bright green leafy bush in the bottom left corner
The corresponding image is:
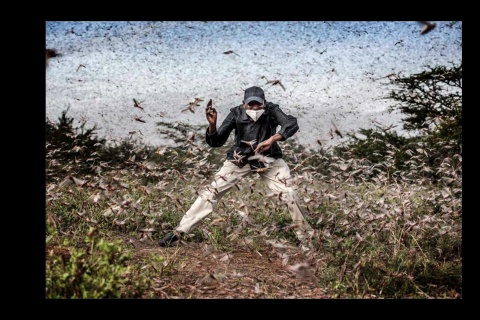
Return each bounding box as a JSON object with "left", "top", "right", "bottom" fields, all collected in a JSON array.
[{"left": 46, "top": 237, "right": 149, "bottom": 299}]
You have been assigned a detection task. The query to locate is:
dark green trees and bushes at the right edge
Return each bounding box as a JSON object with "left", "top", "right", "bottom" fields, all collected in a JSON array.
[{"left": 335, "top": 64, "right": 462, "bottom": 183}]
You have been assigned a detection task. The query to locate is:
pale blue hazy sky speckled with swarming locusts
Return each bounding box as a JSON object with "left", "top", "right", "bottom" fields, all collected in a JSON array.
[{"left": 45, "top": 21, "right": 462, "bottom": 147}]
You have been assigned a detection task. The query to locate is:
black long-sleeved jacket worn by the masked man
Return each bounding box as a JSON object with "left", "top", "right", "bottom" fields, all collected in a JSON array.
[{"left": 205, "top": 102, "right": 298, "bottom": 159}]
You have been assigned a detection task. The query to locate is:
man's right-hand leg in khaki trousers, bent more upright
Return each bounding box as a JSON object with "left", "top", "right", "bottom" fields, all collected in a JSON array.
[{"left": 260, "top": 158, "right": 313, "bottom": 241}]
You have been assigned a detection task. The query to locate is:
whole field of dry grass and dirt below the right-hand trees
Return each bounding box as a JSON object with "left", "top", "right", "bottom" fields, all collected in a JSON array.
[{"left": 46, "top": 111, "right": 462, "bottom": 298}]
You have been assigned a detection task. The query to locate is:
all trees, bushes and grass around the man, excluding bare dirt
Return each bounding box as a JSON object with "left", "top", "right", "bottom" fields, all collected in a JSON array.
[{"left": 46, "top": 62, "right": 463, "bottom": 298}]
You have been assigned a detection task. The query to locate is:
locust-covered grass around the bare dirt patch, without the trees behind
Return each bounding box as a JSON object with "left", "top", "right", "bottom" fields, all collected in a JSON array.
[{"left": 45, "top": 114, "right": 462, "bottom": 298}]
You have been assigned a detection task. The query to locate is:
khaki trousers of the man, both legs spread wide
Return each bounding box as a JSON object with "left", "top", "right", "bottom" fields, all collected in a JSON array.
[{"left": 176, "top": 158, "right": 313, "bottom": 241}]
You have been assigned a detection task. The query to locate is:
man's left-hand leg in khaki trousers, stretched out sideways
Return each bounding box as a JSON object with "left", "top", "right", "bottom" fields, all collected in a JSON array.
[{"left": 175, "top": 160, "right": 250, "bottom": 233}]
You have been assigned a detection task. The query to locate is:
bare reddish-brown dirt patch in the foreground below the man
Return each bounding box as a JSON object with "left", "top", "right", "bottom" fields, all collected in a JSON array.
[{"left": 128, "top": 240, "right": 331, "bottom": 299}]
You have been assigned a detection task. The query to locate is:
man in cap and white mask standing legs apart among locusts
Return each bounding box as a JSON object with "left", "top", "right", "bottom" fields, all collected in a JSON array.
[{"left": 159, "top": 86, "right": 313, "bottom": 247}]
